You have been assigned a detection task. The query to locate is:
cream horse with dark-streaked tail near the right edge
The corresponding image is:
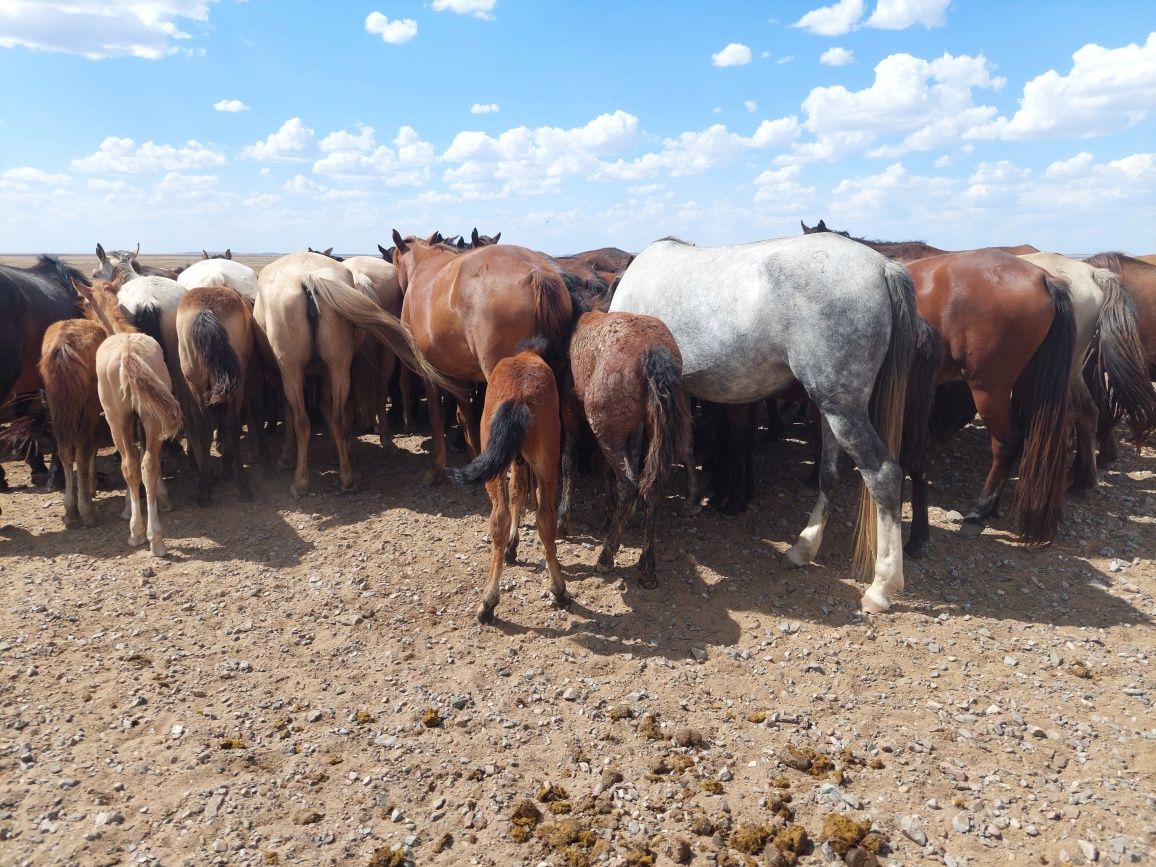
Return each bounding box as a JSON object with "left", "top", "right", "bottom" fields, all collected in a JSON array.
[{"left": 1022, "top": 253, "right": 1156, "bottom": 495}]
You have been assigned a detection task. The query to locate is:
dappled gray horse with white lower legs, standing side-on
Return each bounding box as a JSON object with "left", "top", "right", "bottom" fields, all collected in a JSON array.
[{"left": 610, "top": 234, "right": 935, "bottom": 613}]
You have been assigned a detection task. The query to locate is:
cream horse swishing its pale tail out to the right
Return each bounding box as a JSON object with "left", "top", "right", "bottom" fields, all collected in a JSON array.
[{"left": 253, "top": 253, "right": 454, "bottom": 497}]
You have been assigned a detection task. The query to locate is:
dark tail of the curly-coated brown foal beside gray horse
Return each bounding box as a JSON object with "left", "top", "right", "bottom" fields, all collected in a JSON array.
[{"left": 638, "top": 347, "right": 690, "bottom": 499}]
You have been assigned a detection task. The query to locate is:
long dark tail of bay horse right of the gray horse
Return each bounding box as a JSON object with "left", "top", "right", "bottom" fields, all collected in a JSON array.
[{"left": 1016, "top": 275, "right": 1076, "bottom": 544}]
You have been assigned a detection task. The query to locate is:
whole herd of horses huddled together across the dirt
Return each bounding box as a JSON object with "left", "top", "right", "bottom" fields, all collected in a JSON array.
[{"left": 0, "top": 227, "right": 1156, "bottom": 623}]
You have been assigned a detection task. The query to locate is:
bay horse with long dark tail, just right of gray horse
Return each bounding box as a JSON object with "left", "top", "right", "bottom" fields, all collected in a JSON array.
[{"left": 905, "top": 250, "right": 1075, "bottom": 556}]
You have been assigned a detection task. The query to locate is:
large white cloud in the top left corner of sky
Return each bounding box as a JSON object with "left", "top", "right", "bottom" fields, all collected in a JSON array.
[{"left": 0, "top": 0, "right": 213, "bottom": 60}]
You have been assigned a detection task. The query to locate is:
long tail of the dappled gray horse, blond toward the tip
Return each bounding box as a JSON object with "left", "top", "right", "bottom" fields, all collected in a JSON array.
[{"left": 854, "top": 259, "right": 915, "bottom": 575}]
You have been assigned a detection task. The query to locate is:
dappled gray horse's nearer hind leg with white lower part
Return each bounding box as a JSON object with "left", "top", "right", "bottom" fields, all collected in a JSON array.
[{"left": 800, "top": 405, "right": 903, "bottom": 614}]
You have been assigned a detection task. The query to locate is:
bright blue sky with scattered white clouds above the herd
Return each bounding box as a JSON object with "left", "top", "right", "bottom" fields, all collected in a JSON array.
[{"left": 0, "top": 0, "right": 1156, "bottom": 254}]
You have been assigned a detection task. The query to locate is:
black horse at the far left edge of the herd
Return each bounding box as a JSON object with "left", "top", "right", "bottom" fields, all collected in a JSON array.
[{"left": 0, "top": 255, "right": 84, "bottom": 490}]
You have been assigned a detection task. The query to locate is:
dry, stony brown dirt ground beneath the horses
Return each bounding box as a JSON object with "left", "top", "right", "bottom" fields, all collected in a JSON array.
[{"left": 0, "top": 254, "right": 1156, "bottom": 866}]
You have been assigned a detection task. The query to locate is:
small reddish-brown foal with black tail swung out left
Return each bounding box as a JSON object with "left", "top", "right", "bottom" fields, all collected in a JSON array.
[{"left": 443, "top": 346, "right": 570, "bottom": 623}]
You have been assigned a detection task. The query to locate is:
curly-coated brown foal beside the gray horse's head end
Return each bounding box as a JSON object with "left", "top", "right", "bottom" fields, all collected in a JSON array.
[{"left": 558, "top": 311, "right": 690, "bottom": 587}]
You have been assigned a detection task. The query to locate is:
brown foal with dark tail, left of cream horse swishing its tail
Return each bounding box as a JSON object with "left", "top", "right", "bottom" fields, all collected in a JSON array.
[{"left": 177, "top": 287, "right": 260, "bottom": 506}]
